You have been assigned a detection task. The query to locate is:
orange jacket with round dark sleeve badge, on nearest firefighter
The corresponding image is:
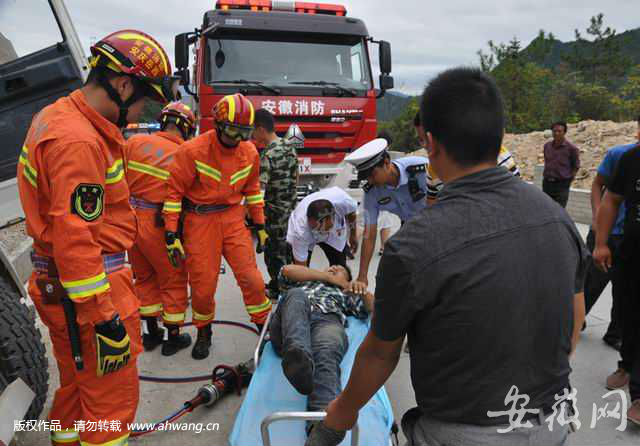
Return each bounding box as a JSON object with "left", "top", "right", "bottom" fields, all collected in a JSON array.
[{"left": 18, "top": 90, "right": 137, "bottom": 323}]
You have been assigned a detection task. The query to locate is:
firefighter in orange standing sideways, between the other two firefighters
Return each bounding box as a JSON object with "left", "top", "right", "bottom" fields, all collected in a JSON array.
[{"left": 125, "top": 102, "right": 196, "bottom": 356}]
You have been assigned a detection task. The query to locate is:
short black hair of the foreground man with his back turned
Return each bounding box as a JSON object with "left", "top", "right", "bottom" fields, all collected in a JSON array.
[{"left": 420, "top": 67, "right": 504, "bottom": 166}]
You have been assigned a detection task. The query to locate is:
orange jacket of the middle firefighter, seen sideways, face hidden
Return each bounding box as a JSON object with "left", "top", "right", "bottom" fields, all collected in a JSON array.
[{"left": 124, "top": 132, "right": 184, "bottom": 203}]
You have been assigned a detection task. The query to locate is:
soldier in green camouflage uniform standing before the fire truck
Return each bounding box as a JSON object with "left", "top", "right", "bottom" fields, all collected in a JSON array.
[{"left": 253, "top": 109, "right": 301, "bottom": 297}]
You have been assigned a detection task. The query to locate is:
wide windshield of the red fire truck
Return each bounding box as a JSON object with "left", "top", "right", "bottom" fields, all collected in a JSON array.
[{"left": 207, "top": 36, "right": 372, "bottom": 95}]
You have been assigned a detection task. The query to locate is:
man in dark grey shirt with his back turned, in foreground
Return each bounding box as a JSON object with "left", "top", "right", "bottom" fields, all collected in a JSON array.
[{"left": 308, "top": 68, "right": 587, "bottom": 446}]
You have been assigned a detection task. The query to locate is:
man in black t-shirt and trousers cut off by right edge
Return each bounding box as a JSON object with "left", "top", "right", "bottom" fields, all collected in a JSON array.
[{"left": 593, "top": 145, "right": 640, "bottom": 425}]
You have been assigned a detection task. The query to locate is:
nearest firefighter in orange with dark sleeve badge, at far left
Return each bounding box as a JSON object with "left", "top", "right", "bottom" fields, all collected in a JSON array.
[{"left": 18, "top": 30, "right": 173, "bottom": 446}]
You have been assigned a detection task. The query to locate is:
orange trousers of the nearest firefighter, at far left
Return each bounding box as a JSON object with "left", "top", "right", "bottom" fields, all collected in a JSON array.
[{"left": 29, "top": 268, "right": 142, "bottom": 446}]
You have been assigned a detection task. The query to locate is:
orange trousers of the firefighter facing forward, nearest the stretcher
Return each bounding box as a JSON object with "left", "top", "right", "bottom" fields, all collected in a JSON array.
[{"left": 183, "top": 205, "right": 271, "bottom": 328}]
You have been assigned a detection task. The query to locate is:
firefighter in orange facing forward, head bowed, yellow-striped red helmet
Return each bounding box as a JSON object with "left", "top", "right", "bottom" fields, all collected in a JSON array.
[{"left": 164, "top": 94, "right": 271, "bottom": 359}]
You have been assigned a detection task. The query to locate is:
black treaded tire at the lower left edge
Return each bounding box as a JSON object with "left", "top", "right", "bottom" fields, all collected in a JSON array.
[{"left": 0, "top": 275, "right": 49, "bottom": 420}]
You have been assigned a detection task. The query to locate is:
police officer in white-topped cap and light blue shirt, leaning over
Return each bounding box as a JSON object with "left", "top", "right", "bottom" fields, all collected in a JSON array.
[{"left": 345, "top": 138, "right": 427, "bottom": 285}]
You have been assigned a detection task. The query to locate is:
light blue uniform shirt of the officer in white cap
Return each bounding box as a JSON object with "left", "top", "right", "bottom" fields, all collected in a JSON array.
[{"left": 364, "top": 156, "right": 428, "bottom": 226}]
